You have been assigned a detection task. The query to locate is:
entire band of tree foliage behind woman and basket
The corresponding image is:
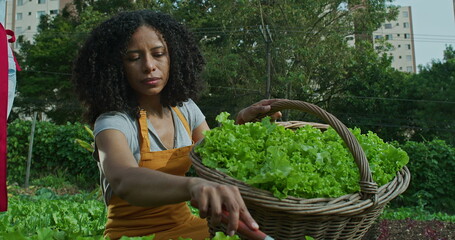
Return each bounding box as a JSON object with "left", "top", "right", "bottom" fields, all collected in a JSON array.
[{"left": 8, "top": 0, "right": 455, "bottom": 143}]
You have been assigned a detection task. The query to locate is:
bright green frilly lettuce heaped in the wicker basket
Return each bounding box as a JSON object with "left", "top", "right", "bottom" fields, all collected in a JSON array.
[{"left": 195, "top": 112, "right": 409, "bottom": 198}]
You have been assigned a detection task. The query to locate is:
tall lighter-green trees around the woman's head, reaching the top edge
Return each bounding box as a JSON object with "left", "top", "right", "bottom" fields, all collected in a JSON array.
[{"left": 13, "top": 0, "right": 395, "bottom": 126}]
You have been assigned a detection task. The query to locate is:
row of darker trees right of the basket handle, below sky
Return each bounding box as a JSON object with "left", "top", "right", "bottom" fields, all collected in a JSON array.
[{"left": 328, "top": 43, "right": 455, "bottom": 145}]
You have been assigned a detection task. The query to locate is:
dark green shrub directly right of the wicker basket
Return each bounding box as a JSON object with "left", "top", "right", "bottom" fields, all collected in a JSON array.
[{"left": 393, "top": 140, "right": 455, "bottom": 214}]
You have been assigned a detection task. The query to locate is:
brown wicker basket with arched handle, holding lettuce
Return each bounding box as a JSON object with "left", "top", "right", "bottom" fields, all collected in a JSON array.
[{"left": 191, "top": 100, "right": 410, "bottom": 240}]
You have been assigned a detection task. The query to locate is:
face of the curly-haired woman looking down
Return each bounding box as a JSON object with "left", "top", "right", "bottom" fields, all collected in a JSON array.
[{"left": 123, "top": 26, "right": 170, "bottom": 100}]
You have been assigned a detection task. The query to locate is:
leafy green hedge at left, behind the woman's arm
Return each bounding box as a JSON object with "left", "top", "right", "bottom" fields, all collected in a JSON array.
[{"left": 8, "top": 120, "right": 99, "bottom": 188}]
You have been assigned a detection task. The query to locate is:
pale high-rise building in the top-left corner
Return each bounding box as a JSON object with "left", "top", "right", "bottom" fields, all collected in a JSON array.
[{"left": 4, "top": 0, "right": 72, "bottom": 48}]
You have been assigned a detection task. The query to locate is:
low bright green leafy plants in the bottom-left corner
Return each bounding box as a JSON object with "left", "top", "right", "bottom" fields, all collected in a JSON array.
[{"left": 0, "top": 193, "right": 106, "bottom": 239}]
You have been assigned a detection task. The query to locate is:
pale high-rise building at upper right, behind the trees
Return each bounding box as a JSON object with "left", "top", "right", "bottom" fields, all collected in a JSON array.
[{"left": 373, "top": 6, "right": 417, "bottom": 73}]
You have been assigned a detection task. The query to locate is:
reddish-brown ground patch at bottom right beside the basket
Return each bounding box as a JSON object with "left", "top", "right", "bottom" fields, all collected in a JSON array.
[{"left": 363, "top": 219, "right": 455, "bottom": 240}]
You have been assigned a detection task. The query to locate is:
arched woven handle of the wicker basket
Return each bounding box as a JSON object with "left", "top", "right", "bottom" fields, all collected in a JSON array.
[{"left": 264, "top": 100, "right": 378, "bottom": 201}]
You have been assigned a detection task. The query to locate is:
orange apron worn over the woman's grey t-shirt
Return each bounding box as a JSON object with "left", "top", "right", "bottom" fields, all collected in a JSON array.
[{"left": 104, "top": 107, "right": 210, "bottom": 240}]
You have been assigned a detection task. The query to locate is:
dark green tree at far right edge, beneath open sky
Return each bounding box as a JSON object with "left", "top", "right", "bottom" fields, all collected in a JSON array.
[{"left": 408, "top": 45, "right": 455, "bottom": 145}]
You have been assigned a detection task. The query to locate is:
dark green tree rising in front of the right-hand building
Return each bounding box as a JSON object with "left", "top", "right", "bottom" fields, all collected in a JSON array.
[{"left": 328, "top": 42, "right": 412, "bottom": 141}]
